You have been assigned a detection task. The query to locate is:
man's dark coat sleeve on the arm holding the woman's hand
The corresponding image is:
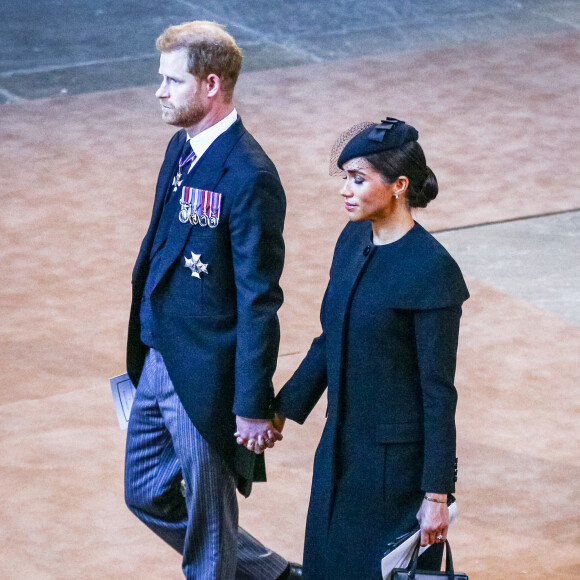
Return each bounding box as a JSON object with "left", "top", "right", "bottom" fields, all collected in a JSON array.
[{"left": 230, "top": 171, "right": 286, "bottom": 419}]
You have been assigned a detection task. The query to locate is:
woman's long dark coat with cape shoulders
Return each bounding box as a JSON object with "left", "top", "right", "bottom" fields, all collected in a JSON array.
[{"left": 275, "top": 221, "right": 469, "bottom": 580}]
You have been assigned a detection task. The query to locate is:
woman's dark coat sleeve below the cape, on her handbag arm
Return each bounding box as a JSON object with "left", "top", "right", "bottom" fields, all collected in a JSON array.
[{"left": 415, "top": 306, "right": 461, "bottom": 493}]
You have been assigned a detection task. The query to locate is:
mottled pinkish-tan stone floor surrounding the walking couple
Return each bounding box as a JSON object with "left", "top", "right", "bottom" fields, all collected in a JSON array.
[{"left": 0, "top": 32, "right": 580, "bottom": 580}]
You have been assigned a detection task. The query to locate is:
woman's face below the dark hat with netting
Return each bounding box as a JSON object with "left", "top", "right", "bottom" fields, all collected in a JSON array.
[{"left": 340, "top": 157, "right": 397, "bottom": 222}]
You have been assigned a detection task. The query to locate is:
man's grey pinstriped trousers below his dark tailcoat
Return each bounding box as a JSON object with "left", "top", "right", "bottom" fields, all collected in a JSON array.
[{"left": 125, "top": 349, "right": 288, "bottom": 580}]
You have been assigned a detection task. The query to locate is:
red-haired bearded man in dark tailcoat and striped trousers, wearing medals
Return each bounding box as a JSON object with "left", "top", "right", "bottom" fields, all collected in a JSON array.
[{"left": 125, "top": 21, "right": 301, "bottom": 580}]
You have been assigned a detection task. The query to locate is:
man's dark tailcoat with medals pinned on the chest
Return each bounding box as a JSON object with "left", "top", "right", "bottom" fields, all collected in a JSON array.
[{"left": 127, "top": 118, "right": 286, "bottom": 495}]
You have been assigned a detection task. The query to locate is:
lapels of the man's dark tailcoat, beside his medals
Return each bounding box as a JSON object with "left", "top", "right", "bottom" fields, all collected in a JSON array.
[{"left": 148, "top": 118, "right": 245, "bottom": 287}]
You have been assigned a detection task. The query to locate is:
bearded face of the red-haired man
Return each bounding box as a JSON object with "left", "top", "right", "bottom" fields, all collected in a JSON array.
[{"left": 155, "top": 48, "right": 209, "bottom": 129}]
